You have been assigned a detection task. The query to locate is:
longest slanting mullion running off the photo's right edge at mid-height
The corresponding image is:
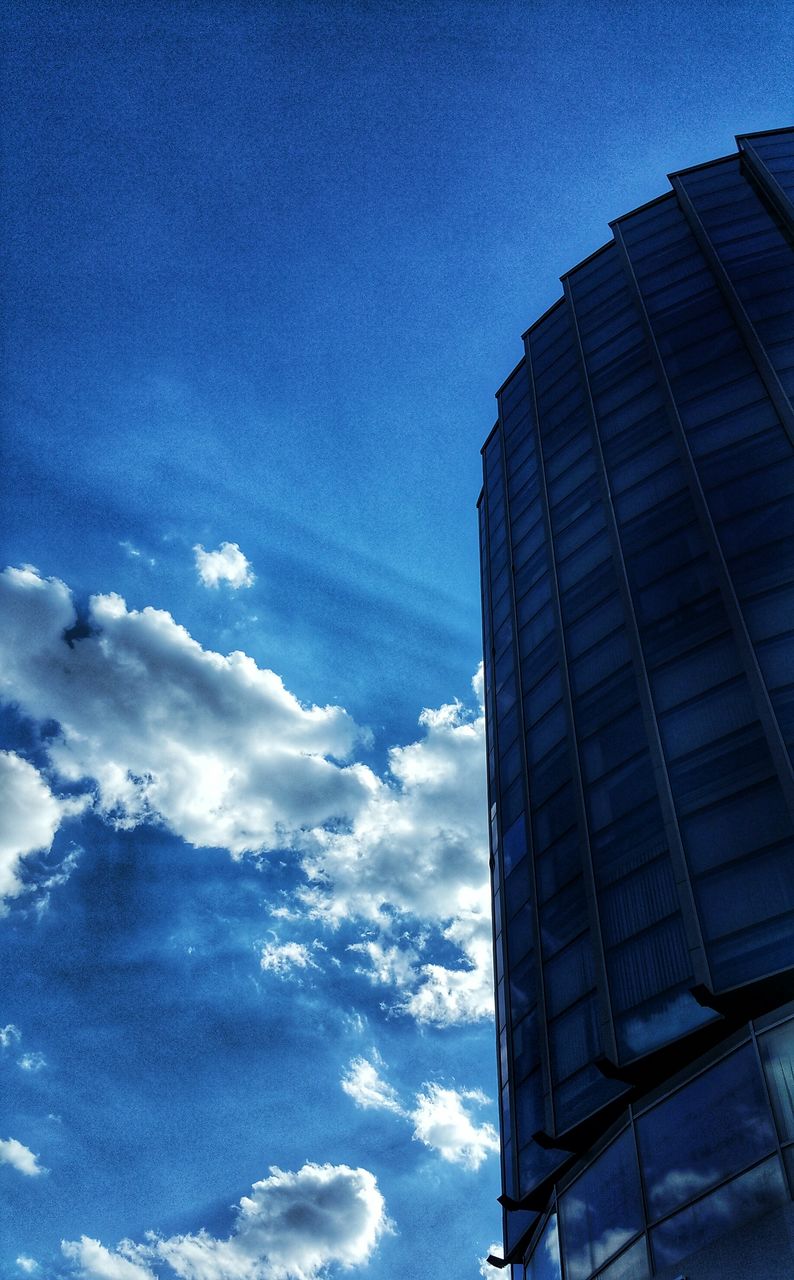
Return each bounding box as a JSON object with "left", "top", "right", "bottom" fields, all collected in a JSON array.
[{"left": 612, "top": 221, "right": 794, "bottom": 860}]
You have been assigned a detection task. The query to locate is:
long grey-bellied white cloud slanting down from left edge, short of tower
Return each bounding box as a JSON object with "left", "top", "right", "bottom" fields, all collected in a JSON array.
[{"left": 0, "top": 568, "right": 374, "bottom": 855}]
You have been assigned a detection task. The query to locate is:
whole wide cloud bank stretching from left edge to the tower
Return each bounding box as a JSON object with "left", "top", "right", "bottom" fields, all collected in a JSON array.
[{"left": 0, "top": 570, "right": 492, "bottom": 1025}]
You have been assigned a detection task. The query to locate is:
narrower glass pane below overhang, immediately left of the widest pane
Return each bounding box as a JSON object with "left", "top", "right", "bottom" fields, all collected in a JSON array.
[{"left": 560, "top": 1129, "right": 643, "bottom": 1280}]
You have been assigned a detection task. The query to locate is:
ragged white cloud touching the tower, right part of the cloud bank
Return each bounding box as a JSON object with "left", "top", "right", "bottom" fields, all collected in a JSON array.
[{"left": 302, "top": 673, "right": 493, "bottom": 1027}]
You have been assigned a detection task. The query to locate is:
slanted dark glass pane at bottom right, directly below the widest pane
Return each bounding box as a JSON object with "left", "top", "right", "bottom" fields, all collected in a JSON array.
[{"left": 651, "top": 1156, "right": 789, "bottom": 1267}]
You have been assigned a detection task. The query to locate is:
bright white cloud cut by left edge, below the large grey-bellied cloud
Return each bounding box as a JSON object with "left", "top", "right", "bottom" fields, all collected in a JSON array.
[{"left": 0, "top": 751, "right": 85, "bottom": 911}]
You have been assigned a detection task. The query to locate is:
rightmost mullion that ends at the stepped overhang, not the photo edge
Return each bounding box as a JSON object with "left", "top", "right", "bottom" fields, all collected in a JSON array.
[{"left": 562, "top": 278, "right": 711, "bottom": 988}]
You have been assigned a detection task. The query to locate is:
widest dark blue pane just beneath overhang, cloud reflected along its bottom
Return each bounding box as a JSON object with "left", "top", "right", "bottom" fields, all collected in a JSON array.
[{"left": 636, "top": 1044, "right": 775, "bottom": 1219}]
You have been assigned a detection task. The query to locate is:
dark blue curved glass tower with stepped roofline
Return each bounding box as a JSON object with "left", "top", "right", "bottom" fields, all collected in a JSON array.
[{"left": 479, "top": 129, "right": 794, "bottom": 1280}]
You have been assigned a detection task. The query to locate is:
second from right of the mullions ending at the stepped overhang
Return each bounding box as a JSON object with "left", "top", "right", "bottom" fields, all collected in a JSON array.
[{"left": 524, "top": 325, "right": 617, "bottom": 1095}]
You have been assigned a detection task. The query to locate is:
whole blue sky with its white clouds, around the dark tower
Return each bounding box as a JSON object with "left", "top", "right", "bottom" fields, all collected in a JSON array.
[{"left": 0, "top": 0, "right": 794, "bottom": 1280}]
